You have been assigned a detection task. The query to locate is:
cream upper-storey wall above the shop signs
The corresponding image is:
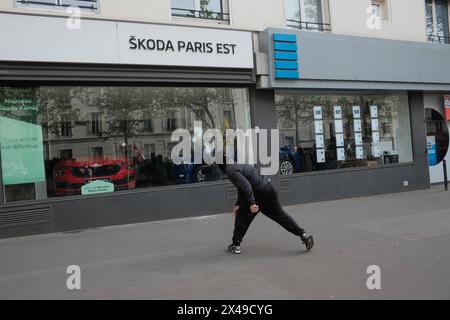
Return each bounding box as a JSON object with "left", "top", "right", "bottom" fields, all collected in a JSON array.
[{"left": 0, "top": 0, "right": 432, "bottom": 41}]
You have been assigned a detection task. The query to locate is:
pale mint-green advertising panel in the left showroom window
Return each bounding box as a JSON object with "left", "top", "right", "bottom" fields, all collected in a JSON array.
[{"left": 0, "top": 116, "right": 45, "bottom": 185}]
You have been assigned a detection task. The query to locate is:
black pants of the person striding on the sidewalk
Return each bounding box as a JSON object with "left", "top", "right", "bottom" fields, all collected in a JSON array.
[{"left": 233, "top": 183, "right": 305, "bottom": 244}]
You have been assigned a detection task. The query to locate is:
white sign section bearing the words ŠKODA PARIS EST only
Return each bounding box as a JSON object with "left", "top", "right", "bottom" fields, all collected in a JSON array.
[{"left": 118, "top": 23, "right": 253, "bottom": 68}]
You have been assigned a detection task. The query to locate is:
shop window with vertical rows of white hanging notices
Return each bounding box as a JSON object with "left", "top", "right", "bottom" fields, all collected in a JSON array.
[{"left": 275, "top": 94, "right": 413, "bottom": 175}]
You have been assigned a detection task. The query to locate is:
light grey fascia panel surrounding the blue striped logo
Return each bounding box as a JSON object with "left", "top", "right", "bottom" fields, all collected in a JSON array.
[{"left": 260, "top": 28, "right": 450, "bottom": 90}]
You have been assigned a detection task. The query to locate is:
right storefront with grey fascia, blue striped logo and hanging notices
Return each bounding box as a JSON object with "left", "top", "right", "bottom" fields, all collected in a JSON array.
[{"left": 256, "top": 28, "right": 450, "bottom": 203}]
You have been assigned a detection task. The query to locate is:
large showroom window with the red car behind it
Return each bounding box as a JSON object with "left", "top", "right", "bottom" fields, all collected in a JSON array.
[{"left": 0, "top": 87, "right": 250, "bottom": 201}]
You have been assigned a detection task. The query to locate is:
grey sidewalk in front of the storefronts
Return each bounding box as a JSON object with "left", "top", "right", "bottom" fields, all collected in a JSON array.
[{"left": 0, "top": 187, "right": 450, "bottom": 299}]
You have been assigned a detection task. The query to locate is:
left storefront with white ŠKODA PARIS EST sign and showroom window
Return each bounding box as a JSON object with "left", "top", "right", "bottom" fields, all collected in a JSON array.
[{"left": 0, "top": 14, "right": 258, "bottom": 237}]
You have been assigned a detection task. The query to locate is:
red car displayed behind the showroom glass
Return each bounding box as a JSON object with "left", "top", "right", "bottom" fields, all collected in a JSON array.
[{"left": 54, "top": 160, "right": 136, "bottom": 196}]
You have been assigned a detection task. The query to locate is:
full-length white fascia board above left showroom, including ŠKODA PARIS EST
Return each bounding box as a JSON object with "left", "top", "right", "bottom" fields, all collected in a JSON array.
[{"left": 0, "top": 13, "right": 253, "bottom": 69}]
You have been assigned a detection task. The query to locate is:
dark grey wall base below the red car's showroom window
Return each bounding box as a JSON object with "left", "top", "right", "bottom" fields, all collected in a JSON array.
[{"left": 0, "top": 181, "right": 239, "bottom": 238}]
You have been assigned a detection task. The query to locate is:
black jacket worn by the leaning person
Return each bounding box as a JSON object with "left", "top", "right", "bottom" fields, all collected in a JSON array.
[{"left": 223, "top": 164, "right": 270, "bottom": 205}]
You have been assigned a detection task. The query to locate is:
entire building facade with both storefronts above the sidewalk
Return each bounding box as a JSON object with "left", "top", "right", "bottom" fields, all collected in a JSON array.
[{"left": 0, "top": 0, "right": 450, "bottom": 237}]
